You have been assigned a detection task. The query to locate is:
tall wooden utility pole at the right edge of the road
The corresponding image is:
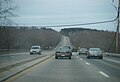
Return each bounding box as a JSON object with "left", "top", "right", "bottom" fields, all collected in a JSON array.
[{"left": 116, "top": 0, "right": 120, "bottom": 53}]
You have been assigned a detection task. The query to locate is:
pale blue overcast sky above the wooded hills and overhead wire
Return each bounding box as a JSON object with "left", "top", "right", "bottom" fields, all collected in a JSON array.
[{"left": 13, "top": 0, "right": 117, "bottom": 30}]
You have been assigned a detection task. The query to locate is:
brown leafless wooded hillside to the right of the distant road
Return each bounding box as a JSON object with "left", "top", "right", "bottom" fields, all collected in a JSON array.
[{"left": 61, "top": 28, "right": 117, "bottom": 52}]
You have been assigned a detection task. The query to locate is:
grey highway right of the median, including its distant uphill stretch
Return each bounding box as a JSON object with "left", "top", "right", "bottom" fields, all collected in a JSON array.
[{"left": 2, "top": 37, "right": 120, "bottom": 82}]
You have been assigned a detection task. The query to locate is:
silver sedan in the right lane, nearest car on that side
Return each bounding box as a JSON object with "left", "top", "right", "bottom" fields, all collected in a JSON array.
[{"left": 87, "top": 48, "right": 103, "bottom": 59}]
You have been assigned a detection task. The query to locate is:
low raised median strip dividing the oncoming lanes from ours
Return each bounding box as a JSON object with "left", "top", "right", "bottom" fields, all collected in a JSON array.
[{"left": 0, "top": 55, "right": 53, "bottom": 82}]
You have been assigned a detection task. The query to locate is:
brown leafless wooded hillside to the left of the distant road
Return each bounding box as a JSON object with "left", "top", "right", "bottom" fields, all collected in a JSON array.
[{"left": 0, "top": 26, "right": 61, "bottom": 49}]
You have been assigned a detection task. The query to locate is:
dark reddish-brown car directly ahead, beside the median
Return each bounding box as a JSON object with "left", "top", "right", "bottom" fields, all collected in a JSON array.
[{"left": 55, "top": 46, "right": 72, "bottom": 59}]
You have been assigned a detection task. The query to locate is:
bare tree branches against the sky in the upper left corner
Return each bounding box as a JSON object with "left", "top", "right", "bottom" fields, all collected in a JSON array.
[{"left": 0, "top": 0, "right": 16, "bottom": 26}]
